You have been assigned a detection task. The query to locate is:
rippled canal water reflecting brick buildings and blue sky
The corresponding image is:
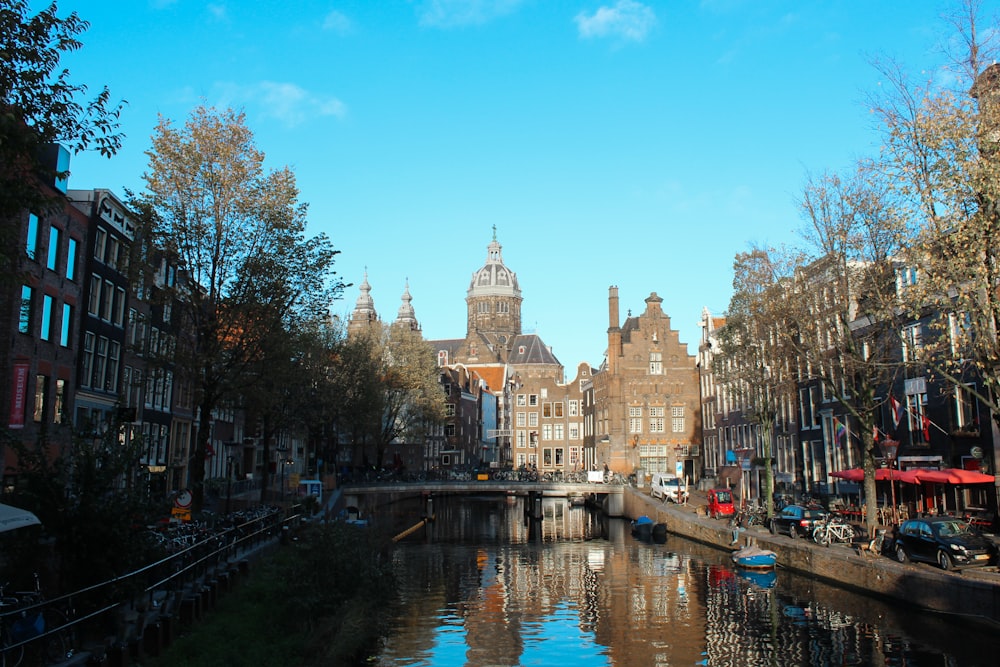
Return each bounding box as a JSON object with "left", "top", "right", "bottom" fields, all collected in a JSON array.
[{"left": 375, "top": 497, "right": 1000, "bottom": 667}]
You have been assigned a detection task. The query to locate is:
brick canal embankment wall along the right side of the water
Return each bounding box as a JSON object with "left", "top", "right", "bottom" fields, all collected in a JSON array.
[{"left": 624, "top": 489, "right": 1000, "bottom": 625}]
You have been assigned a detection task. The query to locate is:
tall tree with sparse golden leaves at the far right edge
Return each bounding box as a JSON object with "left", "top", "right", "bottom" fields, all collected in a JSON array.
[{"left": 872, "top": 0, "right": 1000, "bottom": 496}]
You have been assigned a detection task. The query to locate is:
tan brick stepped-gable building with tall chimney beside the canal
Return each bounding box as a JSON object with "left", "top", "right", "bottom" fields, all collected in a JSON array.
[{"left": 593, "top": 287, "right": 701, "bottom": 482}]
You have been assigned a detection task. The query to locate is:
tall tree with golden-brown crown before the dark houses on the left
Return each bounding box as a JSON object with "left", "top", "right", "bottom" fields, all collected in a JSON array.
[{"left": 141, "top": 106, "right": 343, "bottom": 511}]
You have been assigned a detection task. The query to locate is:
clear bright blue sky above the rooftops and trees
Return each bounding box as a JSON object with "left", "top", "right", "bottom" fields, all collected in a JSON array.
[{"left": 60, "top": 0, "right": 968, "bottom": 379}]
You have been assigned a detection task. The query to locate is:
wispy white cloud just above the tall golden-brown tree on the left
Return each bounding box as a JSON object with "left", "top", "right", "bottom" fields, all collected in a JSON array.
[{"left": 216, "top": 81, "right": 347, "bottom": 127}]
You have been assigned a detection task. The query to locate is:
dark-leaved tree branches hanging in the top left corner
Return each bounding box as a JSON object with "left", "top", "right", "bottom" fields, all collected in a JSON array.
[{"left": 0, "top": 0, "right": 124, "bottom": 276}]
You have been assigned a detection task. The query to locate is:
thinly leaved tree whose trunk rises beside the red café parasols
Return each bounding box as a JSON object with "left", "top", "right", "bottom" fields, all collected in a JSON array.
[{"left": 785, "top": 167, "right": 909, "bottom": 535}]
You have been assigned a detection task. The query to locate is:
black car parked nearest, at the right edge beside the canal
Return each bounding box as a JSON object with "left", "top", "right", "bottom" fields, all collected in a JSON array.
[{"left": 893, "top": 517, "right": 996, "bottom": 570}]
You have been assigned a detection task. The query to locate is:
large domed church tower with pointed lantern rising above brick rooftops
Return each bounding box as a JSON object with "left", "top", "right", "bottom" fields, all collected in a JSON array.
[{"left": 465, "top": 225, "right": 522, "bottom": 359}]
